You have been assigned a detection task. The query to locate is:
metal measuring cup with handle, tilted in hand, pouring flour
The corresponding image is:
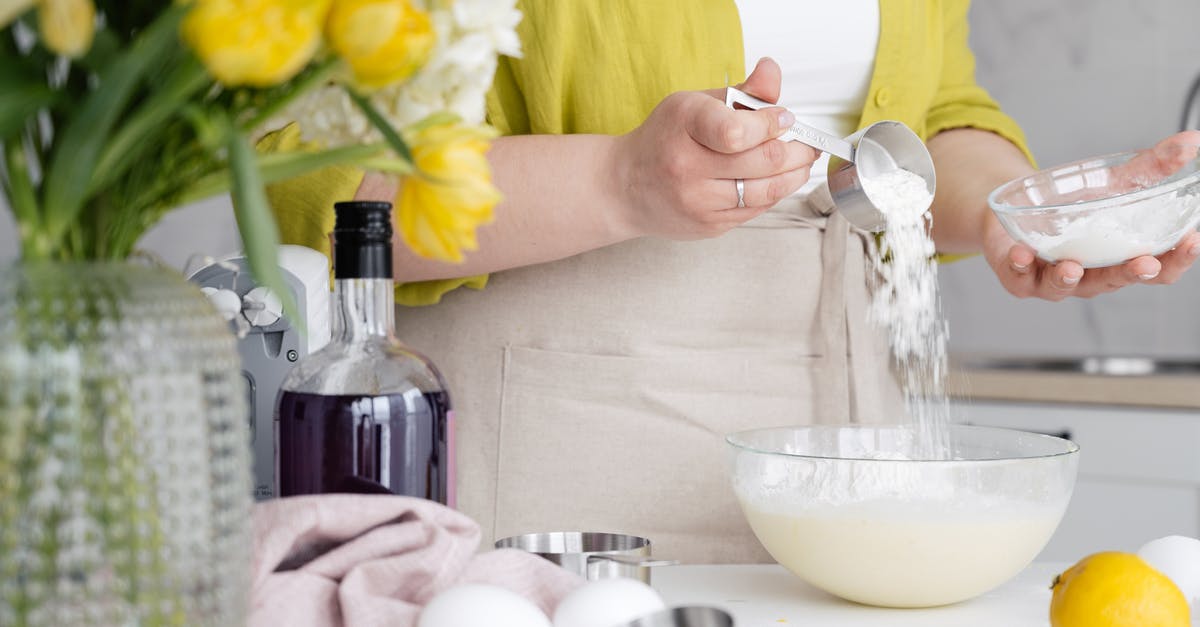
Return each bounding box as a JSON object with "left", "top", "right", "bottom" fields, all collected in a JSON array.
[{"left": 725, "top": 88, "right": 937, "bottom": 233}]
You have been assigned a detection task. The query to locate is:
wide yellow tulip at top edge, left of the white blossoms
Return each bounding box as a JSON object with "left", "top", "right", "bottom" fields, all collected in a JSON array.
[{"left": 182, "top": 0, "right": 330, "bottom": 86}]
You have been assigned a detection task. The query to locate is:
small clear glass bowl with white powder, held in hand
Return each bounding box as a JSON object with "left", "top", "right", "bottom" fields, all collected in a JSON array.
[{"left": 988, "top": 150, "right": 1200, "bottom": 268}]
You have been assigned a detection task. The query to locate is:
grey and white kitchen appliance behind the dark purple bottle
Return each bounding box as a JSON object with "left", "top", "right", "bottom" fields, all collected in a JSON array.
[{"left": 188, "top": 245, "right": 330, "bottom": 501}]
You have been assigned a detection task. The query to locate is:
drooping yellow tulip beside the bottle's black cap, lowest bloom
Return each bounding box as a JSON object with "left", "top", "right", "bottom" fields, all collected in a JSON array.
[{"left": 396, "top": 124, "right": 500, "bottom": 262}]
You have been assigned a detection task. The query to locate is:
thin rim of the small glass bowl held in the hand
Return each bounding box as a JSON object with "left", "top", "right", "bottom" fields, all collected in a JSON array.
[{"left": 988, "top": 150, "right": 1200, "bottom": 215}]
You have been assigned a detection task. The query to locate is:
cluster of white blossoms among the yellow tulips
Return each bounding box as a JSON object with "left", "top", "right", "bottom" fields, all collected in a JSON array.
[{"left": 280, "top": 0, "right": 521, "bottom": 147}]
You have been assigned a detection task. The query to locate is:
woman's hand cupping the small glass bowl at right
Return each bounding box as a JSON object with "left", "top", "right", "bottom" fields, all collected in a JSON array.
[{"left": 983, "top": 131, "right": 1200, "bottom": 300}]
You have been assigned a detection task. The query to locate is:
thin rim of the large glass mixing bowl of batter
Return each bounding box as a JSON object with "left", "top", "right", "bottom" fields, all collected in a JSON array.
[{"left": 725, "top": 424, "right": 1079, "bottom": 465}]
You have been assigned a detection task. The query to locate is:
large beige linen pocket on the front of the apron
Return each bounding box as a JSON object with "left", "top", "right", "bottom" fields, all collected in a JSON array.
[{"left": 496, "top": 346, "right": 821, "bottom": 561}]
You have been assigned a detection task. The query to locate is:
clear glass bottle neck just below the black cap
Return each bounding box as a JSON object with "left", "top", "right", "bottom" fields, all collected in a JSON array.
[{"left": 330, "top": 279, "right": 396, "bottom": 344}]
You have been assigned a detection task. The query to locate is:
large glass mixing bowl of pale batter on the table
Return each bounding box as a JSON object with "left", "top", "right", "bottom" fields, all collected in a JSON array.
[{"left": 726, "top": 426, "right": 1079, "bottom": 608}]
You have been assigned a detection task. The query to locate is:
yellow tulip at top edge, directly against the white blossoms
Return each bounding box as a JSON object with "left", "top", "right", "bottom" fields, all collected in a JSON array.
[{"left": 325, "top": 0, "right": 437, "bottom": 88}]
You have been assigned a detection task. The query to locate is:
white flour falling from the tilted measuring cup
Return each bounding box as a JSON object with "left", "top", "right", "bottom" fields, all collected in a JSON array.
[{"left": 862, "top": 169, "right": 949, "bottom": 459}]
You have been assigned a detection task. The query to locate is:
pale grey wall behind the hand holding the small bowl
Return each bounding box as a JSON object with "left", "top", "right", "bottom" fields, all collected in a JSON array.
[{"left": 941, "top": 0, "right": 1200, "bottom": 357}]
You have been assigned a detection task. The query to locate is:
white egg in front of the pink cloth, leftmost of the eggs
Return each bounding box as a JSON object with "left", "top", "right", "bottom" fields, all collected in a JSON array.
[{"left": 416, "top": 584, "right": 551, "bottom": 627}]
